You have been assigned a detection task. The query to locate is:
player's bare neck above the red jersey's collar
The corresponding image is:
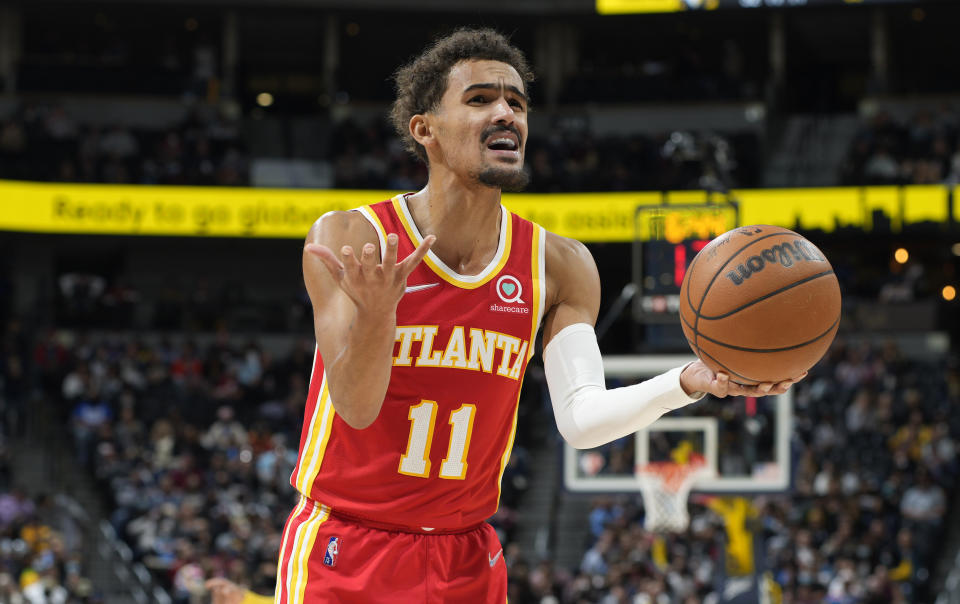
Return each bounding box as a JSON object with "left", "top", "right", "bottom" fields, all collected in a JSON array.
[{"left": 406, "top": 174, "right": 501, "bottom": 275}]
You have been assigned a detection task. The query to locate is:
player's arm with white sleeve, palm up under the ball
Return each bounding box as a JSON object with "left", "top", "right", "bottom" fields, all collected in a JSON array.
[{"left": 543, "top": 234, "right": 802, "bottom": 448}]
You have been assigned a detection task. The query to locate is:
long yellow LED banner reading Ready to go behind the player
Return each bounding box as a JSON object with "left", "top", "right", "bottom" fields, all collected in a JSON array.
[{"left": 0, "top": 181, "right": 948, "bottom": 242}]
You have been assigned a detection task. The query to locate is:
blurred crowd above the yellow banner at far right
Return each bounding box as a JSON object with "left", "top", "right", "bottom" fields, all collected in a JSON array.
[{"left": 839, "top": 105, "right": 960, "bottom": 185}]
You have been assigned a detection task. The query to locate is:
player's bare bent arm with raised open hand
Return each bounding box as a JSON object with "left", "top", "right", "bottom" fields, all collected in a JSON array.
[{"left": 303, "top": 212, "right": 435, "bottom": 430}]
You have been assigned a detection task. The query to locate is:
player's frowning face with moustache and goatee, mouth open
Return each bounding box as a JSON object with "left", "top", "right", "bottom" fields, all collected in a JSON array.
[{"left": 430, "top": 61, "right": 529, "bottom": 191}]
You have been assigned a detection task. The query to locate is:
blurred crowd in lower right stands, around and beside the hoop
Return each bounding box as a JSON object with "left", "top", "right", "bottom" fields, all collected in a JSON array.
[{"left": 528, "top": 342, "right": 960, "bottom": 604}]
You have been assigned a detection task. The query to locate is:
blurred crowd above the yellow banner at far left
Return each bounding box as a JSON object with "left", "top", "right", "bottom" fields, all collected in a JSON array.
[{"left": 0, "top": 103, "right": 249, "bottom": 186}]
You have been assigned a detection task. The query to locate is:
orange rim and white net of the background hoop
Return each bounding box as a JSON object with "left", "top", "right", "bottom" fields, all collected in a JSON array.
[{"left": 637, "top": 455, "right": 710, "bottom": 533}]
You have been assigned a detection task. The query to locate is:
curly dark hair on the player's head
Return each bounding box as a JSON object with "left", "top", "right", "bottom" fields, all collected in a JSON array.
[{"left": 390, "top": 27, "right": 534, "bottom": 163}]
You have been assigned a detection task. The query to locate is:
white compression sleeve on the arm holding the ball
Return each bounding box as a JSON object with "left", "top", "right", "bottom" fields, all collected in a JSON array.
[{"left": 543, "top": 323, "right": 703, "bottom": 449}]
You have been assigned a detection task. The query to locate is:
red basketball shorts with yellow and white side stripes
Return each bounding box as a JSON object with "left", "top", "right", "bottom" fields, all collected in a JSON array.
[{"left": 275, "top": 497, "right": 507, "bottom": 604}]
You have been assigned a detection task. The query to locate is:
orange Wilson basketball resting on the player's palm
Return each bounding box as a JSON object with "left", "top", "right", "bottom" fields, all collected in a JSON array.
[{"left": 680, "top": 225, "right": 840, "bottom": 385}]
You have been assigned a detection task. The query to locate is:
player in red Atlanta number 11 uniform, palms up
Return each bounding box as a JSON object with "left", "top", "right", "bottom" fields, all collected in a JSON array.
[{"left": 275, "top": 30, "right": 792, "bottom": 604}]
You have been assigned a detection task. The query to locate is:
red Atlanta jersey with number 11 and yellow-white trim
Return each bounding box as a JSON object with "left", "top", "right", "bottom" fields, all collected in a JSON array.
[{"left": 291, "top": 195, "right": 545, "bottom": 530}]
